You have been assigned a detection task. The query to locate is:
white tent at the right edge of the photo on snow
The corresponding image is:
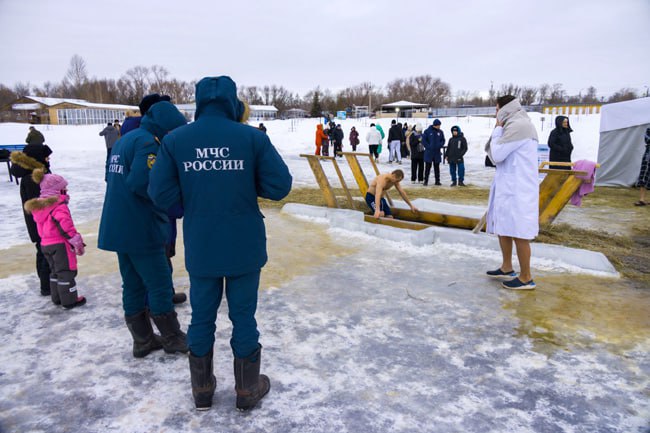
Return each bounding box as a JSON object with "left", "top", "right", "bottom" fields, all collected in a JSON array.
[{"left": 596, "top": 98, "right": 650, "bottom": 186}]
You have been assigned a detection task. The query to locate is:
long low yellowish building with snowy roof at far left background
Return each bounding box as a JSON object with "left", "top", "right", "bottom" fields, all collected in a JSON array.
[{"left": 2, "top": 96, "right": 138, "bottom": 125}]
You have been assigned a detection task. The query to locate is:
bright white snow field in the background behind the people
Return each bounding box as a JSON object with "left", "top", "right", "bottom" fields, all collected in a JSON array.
[{"left": 0, "top": 113, "right": 600, "bottom": 249}]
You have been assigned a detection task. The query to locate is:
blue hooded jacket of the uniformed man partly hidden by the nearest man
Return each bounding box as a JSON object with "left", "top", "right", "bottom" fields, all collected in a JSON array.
[{"left": 97, "top": 102, "right": 187, "bottom": 254}]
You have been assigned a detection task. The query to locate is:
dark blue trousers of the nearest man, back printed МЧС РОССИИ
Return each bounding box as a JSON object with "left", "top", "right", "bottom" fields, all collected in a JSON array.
[{"left": 187, "top": 270, "right": 260, "bottom": 358}]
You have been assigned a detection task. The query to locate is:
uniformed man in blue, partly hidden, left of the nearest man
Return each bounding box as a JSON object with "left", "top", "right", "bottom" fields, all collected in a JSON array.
[{"left": 98, "top": 101, "right": 188, "bottom": 358}]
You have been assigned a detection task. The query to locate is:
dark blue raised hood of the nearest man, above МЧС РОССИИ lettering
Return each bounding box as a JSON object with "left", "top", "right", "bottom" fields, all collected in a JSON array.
[{"left": 194, "top": 75, "right": 247, "bottom": 122}]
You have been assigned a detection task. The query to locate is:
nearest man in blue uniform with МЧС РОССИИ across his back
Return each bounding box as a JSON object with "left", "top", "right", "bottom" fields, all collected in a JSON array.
[{"left": 149, "top": 76, "right": 292, "bottom": 410}]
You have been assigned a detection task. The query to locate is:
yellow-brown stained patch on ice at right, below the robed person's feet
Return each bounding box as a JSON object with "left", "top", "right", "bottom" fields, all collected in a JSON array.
[{"left": 502, "top": 274, "right": 650, "bottom": 354}]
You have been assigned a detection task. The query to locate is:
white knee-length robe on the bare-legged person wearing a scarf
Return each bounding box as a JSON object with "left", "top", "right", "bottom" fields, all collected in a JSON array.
[{"left": 487, "top": 126, "right": 539, "bottom": 239}]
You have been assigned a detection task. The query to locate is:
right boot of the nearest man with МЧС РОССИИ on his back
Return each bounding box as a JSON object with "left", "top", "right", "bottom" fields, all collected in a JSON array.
[{"left": 234, "top": 346, "right": 271, "bottom": 411}]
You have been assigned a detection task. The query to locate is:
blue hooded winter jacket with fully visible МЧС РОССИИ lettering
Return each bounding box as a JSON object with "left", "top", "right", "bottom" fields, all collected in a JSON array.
[{"left": 149, "top": 76, "right": 292, "bottom": 278}]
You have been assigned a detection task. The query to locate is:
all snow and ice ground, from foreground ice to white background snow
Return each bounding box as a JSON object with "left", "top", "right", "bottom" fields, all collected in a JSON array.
[{"left": 0, "top": 114, "right": 650, "bottom": 433}]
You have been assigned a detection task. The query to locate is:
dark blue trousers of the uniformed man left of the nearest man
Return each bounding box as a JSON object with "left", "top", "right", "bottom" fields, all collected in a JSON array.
[{"left": 117, "top": 247, "right": 174, "bottom": 316}]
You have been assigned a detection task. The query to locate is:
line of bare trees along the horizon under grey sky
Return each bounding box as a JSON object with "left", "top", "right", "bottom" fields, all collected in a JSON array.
[{"left": 0, "top": 55, "right": 641, "bottom": 116}]
